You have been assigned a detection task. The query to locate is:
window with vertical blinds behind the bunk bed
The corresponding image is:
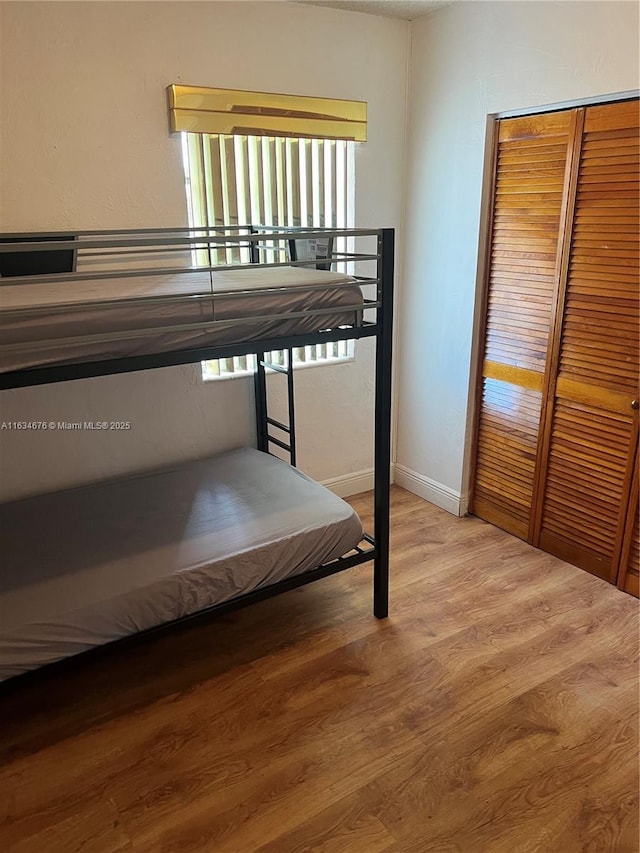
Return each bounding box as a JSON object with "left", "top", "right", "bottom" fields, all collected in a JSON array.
[{"left": 182, "top": 133, "right": 354, "bottom": 379}]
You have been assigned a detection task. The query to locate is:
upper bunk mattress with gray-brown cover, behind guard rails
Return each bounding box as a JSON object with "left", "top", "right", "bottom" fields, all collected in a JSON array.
[{"left": 0, "top": 265, "right": 363, "bottom": 372}]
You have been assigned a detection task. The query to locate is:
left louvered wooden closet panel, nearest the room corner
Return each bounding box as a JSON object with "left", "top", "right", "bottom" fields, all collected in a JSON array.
[{"left": 472, "top": 111, "right": 576, "bottom": 539}]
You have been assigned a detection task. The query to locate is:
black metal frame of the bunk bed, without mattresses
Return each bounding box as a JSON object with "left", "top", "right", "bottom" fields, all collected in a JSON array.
[{"left": 0, "top": 226, "right": 394, "bottom": 694}]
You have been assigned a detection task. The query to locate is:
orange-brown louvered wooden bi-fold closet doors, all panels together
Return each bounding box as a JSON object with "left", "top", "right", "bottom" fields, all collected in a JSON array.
[{"left": 471, "top": 100, "right": 640, "bottom": 594}]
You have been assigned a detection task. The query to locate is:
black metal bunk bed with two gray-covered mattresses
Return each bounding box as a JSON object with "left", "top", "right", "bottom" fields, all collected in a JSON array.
[{"left": 0, "top": 226, "right": 394, "bottom": 687}]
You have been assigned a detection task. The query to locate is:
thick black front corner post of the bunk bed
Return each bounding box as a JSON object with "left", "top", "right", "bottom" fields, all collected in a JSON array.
[{"left": 373, "top": 228, "right": 394, "bottom": 619}]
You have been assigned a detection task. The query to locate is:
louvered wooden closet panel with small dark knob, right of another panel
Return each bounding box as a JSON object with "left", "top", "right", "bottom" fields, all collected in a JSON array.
[{"left": 534, "top": 101, "right": 640, "bottom": 582}]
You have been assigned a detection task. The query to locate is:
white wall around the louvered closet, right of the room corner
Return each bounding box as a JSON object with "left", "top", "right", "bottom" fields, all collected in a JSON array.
[{"left": 395, "top": 2, "right": 639, "bottom": 511}]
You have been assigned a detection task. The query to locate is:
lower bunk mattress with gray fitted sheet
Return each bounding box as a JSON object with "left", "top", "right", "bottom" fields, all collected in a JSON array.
[{"left": 0, "top": 448, "right": 362, "bottom": 680}]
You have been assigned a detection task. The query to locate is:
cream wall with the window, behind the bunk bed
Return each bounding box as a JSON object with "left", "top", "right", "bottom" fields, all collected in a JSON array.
[{"left": 0, "top": 2, "right": 408, "bottom": 499}]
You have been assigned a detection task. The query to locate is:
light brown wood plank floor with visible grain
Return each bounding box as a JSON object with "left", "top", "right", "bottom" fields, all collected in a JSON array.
[{"left": 0, "top": 488, "right": 639, "bottom": 853}]
